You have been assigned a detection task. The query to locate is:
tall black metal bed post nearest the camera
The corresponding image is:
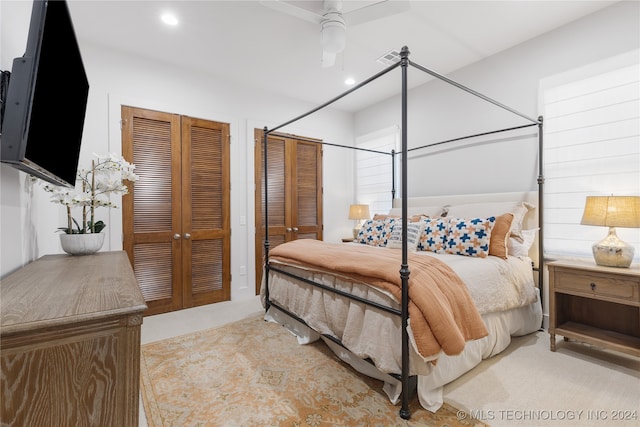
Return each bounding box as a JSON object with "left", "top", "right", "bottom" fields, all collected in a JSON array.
[{"left": 400, "top": 46, "right": 411, "bottom": 420}]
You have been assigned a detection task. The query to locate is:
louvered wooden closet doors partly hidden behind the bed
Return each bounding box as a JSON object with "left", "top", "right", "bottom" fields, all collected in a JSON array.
[{"left": 254, "top": 129, "right": 322, "bottom": 292}]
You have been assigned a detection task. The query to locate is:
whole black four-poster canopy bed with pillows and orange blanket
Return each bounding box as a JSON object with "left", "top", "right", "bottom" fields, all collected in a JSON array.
[{"left": 261, "top": 47, "right": 543, "bottom": 419}]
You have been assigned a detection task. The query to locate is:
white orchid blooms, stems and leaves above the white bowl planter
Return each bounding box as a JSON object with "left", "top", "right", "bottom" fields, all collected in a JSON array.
[{"left": 44, "top": 153, "right": 138, "bottom": 234}]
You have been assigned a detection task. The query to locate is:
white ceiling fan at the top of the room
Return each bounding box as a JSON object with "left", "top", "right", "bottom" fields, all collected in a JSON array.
[{"left": 260, "top": 0, "right": 410, "bottom": 68}]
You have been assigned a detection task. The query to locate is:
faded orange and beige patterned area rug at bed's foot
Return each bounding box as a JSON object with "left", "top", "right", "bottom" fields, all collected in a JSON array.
[{"left": 141, "top": 317, "right": 485, "bottom": 427}]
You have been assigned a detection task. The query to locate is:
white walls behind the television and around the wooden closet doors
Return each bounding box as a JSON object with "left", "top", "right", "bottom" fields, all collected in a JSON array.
[{"left": 0, "top": 2, "right": 354, "bottom": 300}]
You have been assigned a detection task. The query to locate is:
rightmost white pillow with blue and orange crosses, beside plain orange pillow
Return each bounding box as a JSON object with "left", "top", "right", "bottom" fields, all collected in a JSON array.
[{"left": 444, "top": 216, "right": 496, "bottom": 258}]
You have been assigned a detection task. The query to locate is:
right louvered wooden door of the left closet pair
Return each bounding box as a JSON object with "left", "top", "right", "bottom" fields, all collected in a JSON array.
[{"left": 182, "top": 117, "right": 231, "bottom": 307}]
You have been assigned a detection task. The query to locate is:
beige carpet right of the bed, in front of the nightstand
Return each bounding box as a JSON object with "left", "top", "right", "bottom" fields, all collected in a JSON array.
[{"left": 445, "top": 332, "right": 640, "bottom": 427}]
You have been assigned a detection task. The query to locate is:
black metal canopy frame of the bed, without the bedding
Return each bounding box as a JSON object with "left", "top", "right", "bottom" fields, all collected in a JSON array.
[{"left": 263, "top": 46, "right": 544, "bottom": 419}]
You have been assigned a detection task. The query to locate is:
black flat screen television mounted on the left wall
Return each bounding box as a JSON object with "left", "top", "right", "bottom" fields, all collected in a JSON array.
[{"left": 0, "top": 0, "right": 89, "bottom": 187}]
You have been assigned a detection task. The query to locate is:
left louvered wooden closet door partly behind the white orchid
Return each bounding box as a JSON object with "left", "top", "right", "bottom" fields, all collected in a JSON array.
[{"left": 122, "top": 106, "right": 182, "bottom": 315}]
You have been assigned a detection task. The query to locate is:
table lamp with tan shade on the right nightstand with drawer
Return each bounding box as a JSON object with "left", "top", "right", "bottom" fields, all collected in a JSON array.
[{"left": 580, "top": 196, "right": 640, "bottom": 267}]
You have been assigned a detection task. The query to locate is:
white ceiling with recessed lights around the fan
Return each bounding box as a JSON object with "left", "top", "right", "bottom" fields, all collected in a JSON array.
[{"left": 69, "top": 0, "right": 615, "bottom": 111}]
